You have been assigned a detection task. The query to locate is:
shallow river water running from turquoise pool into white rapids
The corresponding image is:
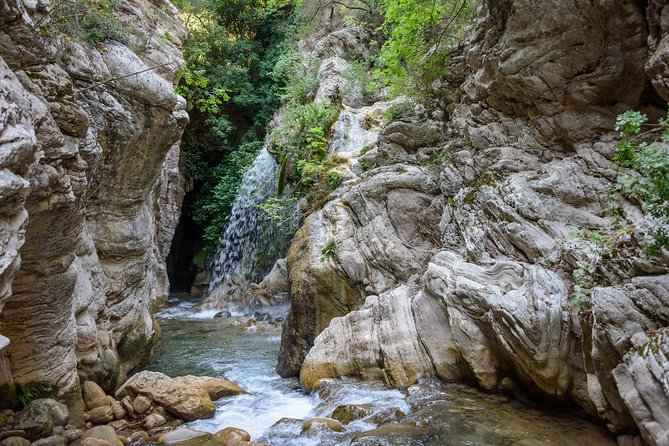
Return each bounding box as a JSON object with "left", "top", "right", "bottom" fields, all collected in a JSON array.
[{"left": 149, "top": 297, "right": 615, "bottom": 446}]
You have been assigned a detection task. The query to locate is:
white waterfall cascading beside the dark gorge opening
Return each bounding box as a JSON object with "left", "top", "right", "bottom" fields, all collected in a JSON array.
[{"left": 205, "top": 147, "right": 279, "bottom": 304}]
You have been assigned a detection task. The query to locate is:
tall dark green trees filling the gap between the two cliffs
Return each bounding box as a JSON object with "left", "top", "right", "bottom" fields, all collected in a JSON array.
[{"left": 175, "top": 0, "right": 297, "bottom": 255}]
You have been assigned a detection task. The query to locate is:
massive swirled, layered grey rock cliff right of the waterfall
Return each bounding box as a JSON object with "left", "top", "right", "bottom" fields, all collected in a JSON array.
[{"left": 278, "top": 0, "right": 669, "bottom": 445}]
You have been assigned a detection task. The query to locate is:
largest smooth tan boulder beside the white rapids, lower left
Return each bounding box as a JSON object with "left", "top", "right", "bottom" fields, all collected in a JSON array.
[{"left": 116, "top": 371, "right": 216, "bottom": 420}]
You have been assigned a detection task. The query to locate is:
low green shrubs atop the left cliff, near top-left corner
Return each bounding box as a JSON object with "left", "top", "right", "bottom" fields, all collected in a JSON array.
[{"left": 44, "top": 0, "right": 127, "bottom": 46}]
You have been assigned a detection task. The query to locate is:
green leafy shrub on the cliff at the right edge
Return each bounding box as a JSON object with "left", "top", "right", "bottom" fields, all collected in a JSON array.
[{"left": 614, "top": 110, "right": 669, "bottom": 256}]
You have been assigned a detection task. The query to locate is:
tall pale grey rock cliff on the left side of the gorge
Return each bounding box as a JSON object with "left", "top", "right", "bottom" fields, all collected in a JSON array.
[{"left": 0, "top": 0, "right": 188, "bottom": 412}]
